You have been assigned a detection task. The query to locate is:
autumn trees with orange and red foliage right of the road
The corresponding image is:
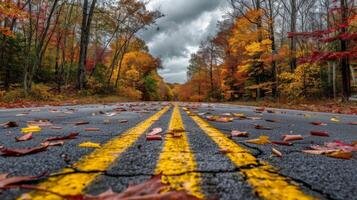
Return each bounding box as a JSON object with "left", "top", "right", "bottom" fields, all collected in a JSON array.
[{"left": 174, "top": 0, "right": 357, "bottom": 102}]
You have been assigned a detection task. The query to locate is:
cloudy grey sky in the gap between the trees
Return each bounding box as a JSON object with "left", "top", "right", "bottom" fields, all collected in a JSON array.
[{"left": 140, "top": 0, "right": 228, "bottom": 83}]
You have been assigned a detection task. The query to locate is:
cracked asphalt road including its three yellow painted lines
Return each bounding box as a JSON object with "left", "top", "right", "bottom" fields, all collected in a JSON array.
[{"left": 0, "top": 102, "right": 357, "bottom": 200}]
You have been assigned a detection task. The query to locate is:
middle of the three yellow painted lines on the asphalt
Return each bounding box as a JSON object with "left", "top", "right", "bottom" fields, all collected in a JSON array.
[{"left": 155, "top": 105, "right": 204, "bottom": 198}]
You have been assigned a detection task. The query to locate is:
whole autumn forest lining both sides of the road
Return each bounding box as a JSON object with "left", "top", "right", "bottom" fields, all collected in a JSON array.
[{"left": 0, "top": 0, "right": 357, "bottom": 102}]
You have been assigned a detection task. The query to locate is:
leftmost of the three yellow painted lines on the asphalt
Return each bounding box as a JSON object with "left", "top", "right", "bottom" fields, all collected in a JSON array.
[{"left": 19, "top": 106, "right": 170, "bottom": 200}]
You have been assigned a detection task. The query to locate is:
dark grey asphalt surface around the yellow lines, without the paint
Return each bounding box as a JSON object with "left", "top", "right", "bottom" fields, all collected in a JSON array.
[{"left": 0, "top": 102, "right": 357, "bottom": 200}]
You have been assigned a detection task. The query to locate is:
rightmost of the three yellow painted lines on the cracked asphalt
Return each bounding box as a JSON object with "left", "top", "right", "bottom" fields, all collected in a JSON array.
[{"left": 185, "top": 109, "right": 316, "bottom": 200}]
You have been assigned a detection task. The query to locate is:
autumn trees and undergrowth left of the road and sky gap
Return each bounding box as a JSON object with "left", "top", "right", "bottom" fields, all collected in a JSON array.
[{"left": 0, "top": 0, "right": 172, "bottom": 101}]
